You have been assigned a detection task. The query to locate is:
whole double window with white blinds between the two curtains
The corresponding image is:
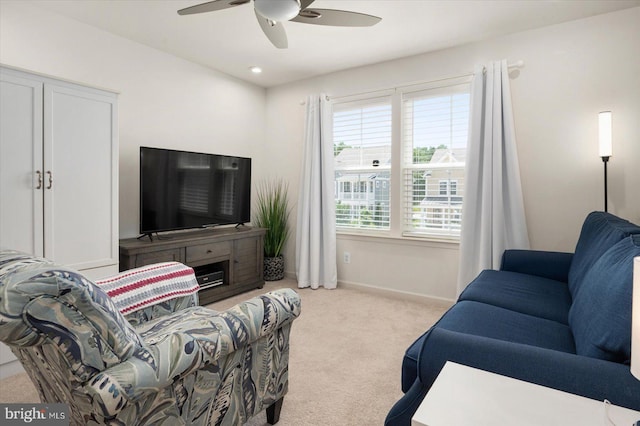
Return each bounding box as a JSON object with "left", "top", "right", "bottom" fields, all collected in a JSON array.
[{"left": 333, "top": 78, "right": 470, "bottom": 239}]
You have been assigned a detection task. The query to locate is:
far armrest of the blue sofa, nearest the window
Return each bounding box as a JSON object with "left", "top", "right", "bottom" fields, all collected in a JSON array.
[{"left": 500, "top": 250, "right": 573, "bottom": 283}]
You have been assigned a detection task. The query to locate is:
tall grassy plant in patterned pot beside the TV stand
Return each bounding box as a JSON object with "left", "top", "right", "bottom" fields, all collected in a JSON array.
[{"left": 253, "top": 180, "right": 290, "bottom": 281}]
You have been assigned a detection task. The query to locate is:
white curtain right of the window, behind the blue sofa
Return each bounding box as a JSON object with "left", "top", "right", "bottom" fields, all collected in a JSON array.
[{"left": 458, "top": 60, "right": 528, "bottom": 293}]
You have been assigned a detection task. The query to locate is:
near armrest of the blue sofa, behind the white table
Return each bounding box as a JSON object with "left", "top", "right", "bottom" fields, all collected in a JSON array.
[{"left": 418, "top": 328, "right": 640, "bottom": 410}]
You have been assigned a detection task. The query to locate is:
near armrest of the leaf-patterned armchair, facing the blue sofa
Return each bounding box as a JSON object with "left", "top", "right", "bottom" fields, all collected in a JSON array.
[{"left": 83, "top": 289, "right": 300, "bottom": 419}]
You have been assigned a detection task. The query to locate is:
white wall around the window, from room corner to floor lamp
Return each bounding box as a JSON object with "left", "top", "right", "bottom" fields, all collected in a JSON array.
[{"left": 265, "top": 8, "right": 640, "bottom": 299}]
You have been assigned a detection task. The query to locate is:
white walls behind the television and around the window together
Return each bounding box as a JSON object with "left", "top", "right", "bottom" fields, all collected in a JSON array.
[{"left": 0, "top": 2, "right": 640, "bottom": 299}]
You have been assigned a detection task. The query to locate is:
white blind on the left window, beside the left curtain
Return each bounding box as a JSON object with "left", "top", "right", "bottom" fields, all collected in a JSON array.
[{"left": 333, "top": 97, "right": 392, "bottom": 230}]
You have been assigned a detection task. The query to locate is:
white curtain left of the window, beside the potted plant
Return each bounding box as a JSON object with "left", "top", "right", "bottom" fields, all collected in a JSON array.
[{"left": 296, "top": 95, "right": 338, "bottom": 289}]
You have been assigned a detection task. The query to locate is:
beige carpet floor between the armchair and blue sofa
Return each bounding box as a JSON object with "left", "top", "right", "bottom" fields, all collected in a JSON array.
[{"left": 0, "top": 279, "right": 448, "bottom": 426}]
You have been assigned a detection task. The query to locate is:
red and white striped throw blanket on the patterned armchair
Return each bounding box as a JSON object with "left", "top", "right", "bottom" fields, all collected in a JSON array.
[{"left": 95, "top": 262, "right": 200, "bottom": 314}]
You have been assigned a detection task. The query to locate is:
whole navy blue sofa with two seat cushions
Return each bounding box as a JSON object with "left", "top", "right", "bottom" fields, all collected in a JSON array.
[{"left": 385, "top": 212, "right": 640, "bottom": 426}]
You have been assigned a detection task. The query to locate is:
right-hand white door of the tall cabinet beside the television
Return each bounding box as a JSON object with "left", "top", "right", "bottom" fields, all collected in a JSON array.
[{"left": 44, "top": 83, "right": 118, "bottom": 269}]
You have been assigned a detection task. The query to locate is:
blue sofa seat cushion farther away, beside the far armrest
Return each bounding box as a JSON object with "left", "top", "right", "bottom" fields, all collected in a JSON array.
[{"left": 459, "top": 270, "right": 571, "bottom": 324}]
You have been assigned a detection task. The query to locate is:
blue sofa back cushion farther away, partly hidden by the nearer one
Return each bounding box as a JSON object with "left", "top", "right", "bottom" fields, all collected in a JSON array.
[{"left": 569, "top": 212, "right": 640, "bottom": 299}]
